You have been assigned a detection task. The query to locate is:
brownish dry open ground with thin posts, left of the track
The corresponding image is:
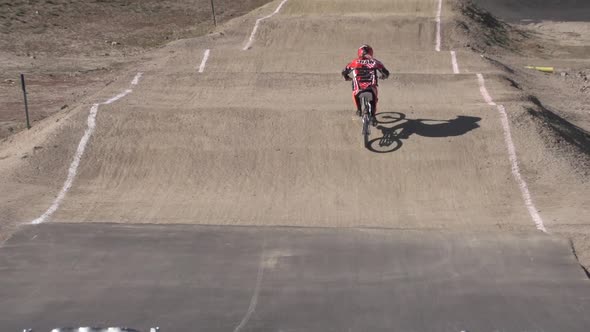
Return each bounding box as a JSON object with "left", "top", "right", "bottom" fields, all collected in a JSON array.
[{"left": 0, "top": 0, "right": 269, "bottom": 139}]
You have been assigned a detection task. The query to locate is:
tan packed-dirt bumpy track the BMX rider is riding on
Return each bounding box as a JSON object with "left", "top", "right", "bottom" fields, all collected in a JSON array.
[{"left": 0, "top": 0, "right": 590, "bottom": 274}]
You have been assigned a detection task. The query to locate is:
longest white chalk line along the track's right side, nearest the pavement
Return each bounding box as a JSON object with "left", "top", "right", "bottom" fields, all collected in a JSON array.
[{"left": 477, "top": 74, "right": 547, "bottom": 233}]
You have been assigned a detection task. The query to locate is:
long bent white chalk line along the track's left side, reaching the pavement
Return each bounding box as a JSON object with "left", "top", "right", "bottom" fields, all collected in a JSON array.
[{"left": 31, "top": 73, "right": 142, "bottom": 224}]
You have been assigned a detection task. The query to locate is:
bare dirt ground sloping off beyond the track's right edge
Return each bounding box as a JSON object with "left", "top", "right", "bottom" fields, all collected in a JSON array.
[{"left": 456, "top": 0, "right": 590, "bottom": 267}]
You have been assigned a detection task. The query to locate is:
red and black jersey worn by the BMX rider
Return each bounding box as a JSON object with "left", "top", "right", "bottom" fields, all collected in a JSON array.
[{"left": 342, "top": 58, "right": 389, "bottom": 92}]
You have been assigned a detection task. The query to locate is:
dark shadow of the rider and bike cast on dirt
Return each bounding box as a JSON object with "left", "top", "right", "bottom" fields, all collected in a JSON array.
[{"left": 367, "top": 112, "right": 481, "bottom": 153}]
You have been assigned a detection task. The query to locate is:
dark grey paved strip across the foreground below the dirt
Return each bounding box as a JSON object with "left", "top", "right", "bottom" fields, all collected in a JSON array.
[{"left": 0, "top": 224, "right": 590, "bottom": 332}]
